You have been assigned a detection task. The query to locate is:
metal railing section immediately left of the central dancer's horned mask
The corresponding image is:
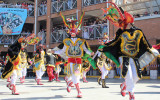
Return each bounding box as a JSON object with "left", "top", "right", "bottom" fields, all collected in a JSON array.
[{"left": 50, "top": 30, "right": 69, "bottom": 43}]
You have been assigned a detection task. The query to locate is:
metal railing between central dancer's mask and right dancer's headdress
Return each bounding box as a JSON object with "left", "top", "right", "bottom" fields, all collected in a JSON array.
[{"left": 82, "top": 24, "right": 108, "bottom": 40}]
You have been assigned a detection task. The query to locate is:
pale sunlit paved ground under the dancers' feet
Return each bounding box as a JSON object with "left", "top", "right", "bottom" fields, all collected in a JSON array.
[{"left": 0, "top": 78, "right": 160, "bottom": 100}]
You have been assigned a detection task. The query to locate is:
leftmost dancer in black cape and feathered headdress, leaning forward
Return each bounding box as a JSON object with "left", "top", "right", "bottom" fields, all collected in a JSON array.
[{"left": 1, "top": 34, "right": 40, "bottom": 95}]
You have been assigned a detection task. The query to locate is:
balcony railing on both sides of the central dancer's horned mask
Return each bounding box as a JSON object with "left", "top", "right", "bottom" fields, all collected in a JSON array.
[{"left": 50, "top": 23, "right": 108, "bottom": 43}]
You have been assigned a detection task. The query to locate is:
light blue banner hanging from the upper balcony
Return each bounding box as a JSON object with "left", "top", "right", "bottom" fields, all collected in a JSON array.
[{"left": 0, "top": 8, "right": 27, "bottom": 35}]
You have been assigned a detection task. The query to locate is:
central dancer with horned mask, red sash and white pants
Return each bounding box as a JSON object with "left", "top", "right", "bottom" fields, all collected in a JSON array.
[{"left": 52, "top": 13, "right": 94, "bottom": 98}]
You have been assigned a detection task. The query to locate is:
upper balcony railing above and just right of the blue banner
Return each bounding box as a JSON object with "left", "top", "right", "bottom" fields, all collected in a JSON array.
[{"left": 0, "top": 4, "right": 34, "bottom": 16}]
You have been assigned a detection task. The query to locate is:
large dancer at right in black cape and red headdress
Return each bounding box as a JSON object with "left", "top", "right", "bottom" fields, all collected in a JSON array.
[{"left": 99, "top": 2, "right": 159, "bottom": 100}]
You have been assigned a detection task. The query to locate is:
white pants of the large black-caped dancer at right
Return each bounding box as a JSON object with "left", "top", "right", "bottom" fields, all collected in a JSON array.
[{"left": 120, "top": 58, "right": 139, "bottom": 92}]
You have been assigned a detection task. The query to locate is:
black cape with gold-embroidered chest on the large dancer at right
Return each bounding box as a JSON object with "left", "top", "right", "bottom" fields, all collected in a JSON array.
[{"left": 98, "top": 28, "right": 159, "bottom": 68}]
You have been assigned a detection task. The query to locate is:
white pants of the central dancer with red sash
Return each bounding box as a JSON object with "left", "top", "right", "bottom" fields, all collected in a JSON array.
[{"left": 69, "top": 63, "right": 81, "bottom": 84}]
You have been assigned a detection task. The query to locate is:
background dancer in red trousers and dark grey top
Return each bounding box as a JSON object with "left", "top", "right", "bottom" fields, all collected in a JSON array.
[{"left": 46, "top": 49, "right": 56, "bottom": 82}]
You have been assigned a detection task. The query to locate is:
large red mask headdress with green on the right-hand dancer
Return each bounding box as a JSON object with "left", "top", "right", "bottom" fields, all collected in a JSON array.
[{"left": 102, "top": 2, "right": 134, "bottom": 29}]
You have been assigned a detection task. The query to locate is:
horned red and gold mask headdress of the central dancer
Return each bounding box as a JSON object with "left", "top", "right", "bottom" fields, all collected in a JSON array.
[{"left": 60, "top": 12, "right": 84, "bottom": 34}]
